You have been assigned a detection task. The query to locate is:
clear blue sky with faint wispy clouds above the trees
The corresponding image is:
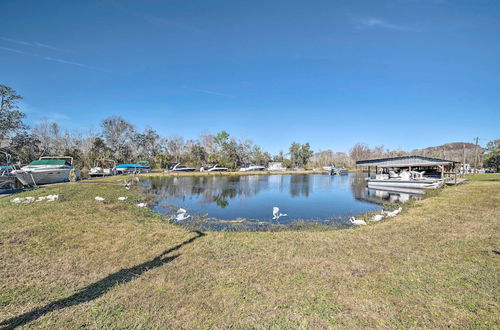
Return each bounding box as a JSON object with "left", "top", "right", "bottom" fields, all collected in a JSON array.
[{"left": 0, "top": 0, "right": 500, "bottom": 152}]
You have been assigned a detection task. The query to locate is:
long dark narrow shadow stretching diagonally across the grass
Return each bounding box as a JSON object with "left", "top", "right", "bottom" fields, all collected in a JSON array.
[{"left": 0, "top": 231, "right": 205, "bottom": 329}]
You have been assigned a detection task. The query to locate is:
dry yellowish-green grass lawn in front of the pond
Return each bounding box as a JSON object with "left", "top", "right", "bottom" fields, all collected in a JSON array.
[{"left": 0, "top": 175, "right": 500, "bottom": 328}]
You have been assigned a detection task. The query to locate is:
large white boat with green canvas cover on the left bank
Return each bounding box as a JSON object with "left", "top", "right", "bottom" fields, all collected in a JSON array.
[{"left": 12, "top": 157, "right": 80, "bottom": 186}]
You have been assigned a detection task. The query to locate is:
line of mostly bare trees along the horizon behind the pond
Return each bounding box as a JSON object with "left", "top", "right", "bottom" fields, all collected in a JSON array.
[{"left": 0, "top": 85, "right": 500, "bottom": 173}]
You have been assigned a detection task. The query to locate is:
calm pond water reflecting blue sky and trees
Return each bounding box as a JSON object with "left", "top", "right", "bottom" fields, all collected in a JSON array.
[{"left": 141, "top": 174, "right": 418, "bottom": 229}]
